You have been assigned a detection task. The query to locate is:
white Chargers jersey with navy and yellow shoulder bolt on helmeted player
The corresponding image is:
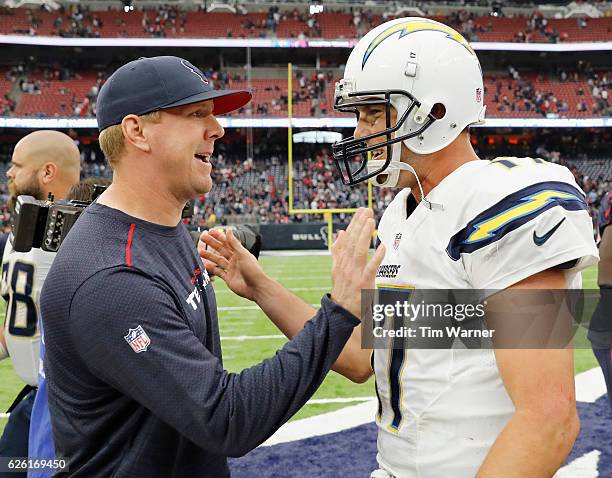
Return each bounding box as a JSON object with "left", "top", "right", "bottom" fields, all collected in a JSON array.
[{"left": 373, "top": 158, "right": 598, "bottom": 478}]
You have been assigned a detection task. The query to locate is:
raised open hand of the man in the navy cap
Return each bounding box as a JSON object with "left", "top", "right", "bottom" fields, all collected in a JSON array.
[{"left": 332, "top": 208, "right": 385, "bottom": 317}]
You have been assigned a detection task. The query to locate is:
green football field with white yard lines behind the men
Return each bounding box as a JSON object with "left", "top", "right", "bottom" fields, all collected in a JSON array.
[{"left": 0, "top": 255, "right": 597, "bottom": 436}]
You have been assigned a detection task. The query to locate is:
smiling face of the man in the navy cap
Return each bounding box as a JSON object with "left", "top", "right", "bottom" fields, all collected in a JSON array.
[{"left": 146, "top": 100, "right": 225, "bottom": 200}]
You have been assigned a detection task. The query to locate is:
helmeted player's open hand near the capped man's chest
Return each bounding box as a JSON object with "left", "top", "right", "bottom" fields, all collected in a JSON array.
[{"left": 198, "top": 228, "right": 267, "bottom": 300}]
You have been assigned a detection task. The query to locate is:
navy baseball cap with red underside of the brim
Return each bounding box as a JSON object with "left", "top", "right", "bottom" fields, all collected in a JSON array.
[{"left": 96, "top": 56, "right": 252, "bottom": 131}]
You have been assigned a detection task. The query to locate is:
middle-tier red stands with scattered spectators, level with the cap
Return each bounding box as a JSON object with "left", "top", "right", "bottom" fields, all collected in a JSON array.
[{"left": 0, "top": 61, "right": 612, "bottom": 117}]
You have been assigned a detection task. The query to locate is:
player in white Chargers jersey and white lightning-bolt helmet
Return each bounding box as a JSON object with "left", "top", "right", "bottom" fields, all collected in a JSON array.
[{"left": 333, "top": 18, "right": 598, "bottom": 478}]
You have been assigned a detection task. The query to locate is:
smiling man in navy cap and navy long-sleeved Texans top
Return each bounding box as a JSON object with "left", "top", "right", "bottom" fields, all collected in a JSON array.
[{"left": 41, "top": 56, "right": 382, "bottom": 478}]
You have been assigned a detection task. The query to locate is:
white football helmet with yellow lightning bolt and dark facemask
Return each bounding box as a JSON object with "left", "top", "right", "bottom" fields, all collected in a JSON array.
[{"left": 333, "top": 17, "right": 486, "bottom": 187}]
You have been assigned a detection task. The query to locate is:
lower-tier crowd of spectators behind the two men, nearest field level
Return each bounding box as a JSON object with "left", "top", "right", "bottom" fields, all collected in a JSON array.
[{"left": 0, "top": 135, "right": 612, "bottom": 231}]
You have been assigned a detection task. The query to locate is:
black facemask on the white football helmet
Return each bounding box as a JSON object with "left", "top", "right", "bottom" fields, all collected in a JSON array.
[{"left": 332, "top": 80, "right": 436, "bottom": 186}]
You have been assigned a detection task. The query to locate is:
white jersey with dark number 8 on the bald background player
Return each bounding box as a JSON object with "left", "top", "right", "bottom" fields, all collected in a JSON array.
[{"left": 0, "top": 238, "right": 55, "bottom": 386}]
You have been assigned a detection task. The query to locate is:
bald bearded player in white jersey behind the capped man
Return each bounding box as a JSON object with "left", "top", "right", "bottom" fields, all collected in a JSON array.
[{"left": 0, "top": 130, "right": 81, "bottom": 466}]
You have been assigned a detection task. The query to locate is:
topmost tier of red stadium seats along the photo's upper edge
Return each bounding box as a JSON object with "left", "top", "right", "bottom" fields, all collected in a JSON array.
[{"left": 0, "top": 8, "right": 612, "bottom": 43}]
